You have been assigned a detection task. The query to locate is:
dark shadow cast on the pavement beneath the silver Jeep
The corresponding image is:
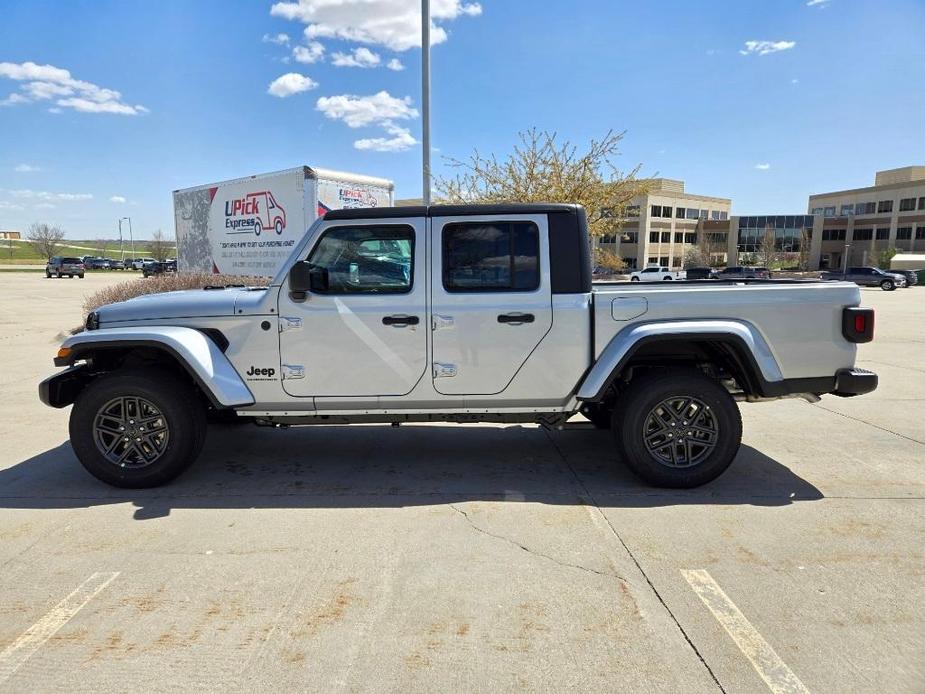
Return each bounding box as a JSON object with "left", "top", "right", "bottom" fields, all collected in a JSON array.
[{"left": 0, "top": 424, "right": 823, "bottom": 520}]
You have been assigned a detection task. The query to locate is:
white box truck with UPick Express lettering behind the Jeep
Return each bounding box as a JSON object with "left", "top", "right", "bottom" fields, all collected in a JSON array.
[{"left": 173, "top": 166, "right": 394, "bottom": 276}]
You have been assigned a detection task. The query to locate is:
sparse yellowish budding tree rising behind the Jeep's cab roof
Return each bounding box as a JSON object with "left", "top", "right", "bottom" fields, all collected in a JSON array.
[{"left": 434, "top": 128, "right": 644, "bottom": 238}]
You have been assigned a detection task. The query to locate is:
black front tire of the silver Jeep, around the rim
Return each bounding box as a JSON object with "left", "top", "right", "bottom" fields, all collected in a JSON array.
[{"left": 69, "top": 368, "right": 207, "bottom": 489}]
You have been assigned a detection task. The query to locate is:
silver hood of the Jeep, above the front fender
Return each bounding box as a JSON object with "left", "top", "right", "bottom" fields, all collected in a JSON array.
[{"left": 95, "top": 287, "right": 266, "bottom": 325}]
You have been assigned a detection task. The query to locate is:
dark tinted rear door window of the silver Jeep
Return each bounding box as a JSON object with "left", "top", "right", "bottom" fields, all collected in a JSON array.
[{"left": 443, "top": 222, "right": 540, "bottom": 292}]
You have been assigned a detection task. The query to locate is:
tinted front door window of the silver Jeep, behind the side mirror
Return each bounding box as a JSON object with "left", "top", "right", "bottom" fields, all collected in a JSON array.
[{"left": 308, "top": 225, "right": 414, "bottom": 294}]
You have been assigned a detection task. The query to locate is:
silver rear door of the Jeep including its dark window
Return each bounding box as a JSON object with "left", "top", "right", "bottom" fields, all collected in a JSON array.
[{"left": 431, "top": 215, "right": 552, "bottom": 395}]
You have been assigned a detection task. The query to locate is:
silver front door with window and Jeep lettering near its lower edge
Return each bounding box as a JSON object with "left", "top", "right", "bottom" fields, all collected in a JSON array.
[{"left": 279, "top": 218, "right": 428, "bottom": 397}]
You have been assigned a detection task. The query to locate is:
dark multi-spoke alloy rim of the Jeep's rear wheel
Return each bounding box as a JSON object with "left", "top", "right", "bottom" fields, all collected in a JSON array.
[{"left": 642, "top": 396, "right": 719, "bottom": 469}]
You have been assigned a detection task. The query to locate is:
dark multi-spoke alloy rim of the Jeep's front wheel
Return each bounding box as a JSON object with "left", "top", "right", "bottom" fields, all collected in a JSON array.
[{"left": 93, "top": 396, "right": 170, "bottom": 469}]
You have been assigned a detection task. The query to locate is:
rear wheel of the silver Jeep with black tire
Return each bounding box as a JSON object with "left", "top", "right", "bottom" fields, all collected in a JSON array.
[{"left": 611, "top": 369, "right": 742, "bottom": 489}]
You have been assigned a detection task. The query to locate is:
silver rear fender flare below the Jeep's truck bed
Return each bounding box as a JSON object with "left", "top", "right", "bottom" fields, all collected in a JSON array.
[{"left": 576, "top": 320, "right": 784, "bottom": 402}]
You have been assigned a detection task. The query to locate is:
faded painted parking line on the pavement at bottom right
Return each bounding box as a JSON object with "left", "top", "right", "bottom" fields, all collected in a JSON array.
[{"left": 681, "top": 569, "right": 809, "bottom": 694}]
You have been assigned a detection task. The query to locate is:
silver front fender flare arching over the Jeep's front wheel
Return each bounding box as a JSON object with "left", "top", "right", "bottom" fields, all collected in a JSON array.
[{"left": 53, "top": 326, "right": 254, "bottom": 407}]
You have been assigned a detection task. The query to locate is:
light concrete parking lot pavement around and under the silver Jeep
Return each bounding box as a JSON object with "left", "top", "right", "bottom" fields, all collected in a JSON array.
[{"left": 0, "top": 273, "right": 925, "bottom": 692}]
